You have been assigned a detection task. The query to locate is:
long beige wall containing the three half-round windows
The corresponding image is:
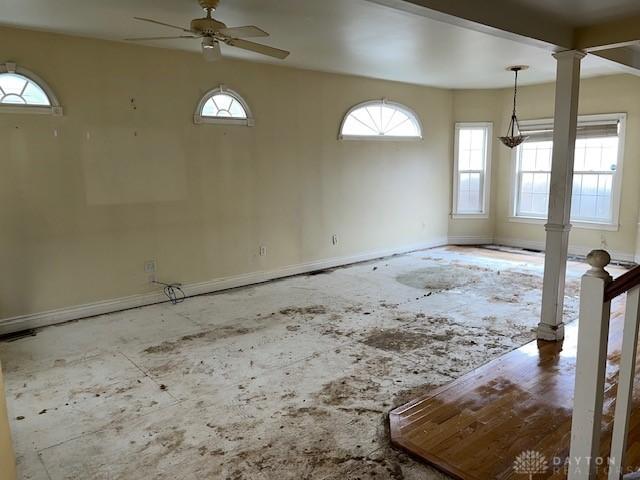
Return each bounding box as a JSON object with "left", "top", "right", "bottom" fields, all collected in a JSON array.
[{"left": 0, "top": 25, "right": 453, "bottom": 319}]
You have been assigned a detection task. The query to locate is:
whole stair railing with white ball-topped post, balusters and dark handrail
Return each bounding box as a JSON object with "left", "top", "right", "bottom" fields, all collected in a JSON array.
[{"left": 568, "top": 250, "right": 640, "bottom": 480}]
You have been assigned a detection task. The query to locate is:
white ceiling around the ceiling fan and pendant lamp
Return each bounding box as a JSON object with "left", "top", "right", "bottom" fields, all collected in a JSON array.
[{"left": 0, "top": 0, "right": 640, "bottom": 88}]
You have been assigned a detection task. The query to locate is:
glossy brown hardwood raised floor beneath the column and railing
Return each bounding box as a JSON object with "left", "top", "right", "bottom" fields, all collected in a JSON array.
[{"left": 390, "top": 299, "right": 640, "bottom": 480}]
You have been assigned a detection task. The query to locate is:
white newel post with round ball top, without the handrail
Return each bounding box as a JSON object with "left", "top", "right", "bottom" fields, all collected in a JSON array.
[{"left": 569, "top": 250, "right": 612, "bottom": 480}]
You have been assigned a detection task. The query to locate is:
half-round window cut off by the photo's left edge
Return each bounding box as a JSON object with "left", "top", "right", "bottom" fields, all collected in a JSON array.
[{"left": 0, "top": 63, "right": 62, "bottom": 115}]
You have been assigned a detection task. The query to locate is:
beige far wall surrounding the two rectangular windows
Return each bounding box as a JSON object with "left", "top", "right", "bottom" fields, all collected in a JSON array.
[{"left": 450, "top": 75, "right": 640, "bottom": 258}]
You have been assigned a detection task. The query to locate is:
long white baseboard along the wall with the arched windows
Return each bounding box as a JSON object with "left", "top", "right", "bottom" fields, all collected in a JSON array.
[{"left": 0, "top": 238, "right": 447, "bottom": 335}]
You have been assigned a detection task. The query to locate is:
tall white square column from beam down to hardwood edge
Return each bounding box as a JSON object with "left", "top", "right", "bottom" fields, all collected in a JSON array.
[{"left": 538, "top": 50, "right": 585, "bottom": 340}]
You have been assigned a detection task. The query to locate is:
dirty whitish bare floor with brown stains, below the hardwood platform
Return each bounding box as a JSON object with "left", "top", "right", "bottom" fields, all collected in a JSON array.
[{"left": 0, "top": 247, "right": 608, "bottom": 480}]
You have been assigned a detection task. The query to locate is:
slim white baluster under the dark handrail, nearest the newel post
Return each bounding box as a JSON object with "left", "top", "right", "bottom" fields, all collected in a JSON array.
[{"left": 609, "top": 287, "right": 640, "bottom": 480}]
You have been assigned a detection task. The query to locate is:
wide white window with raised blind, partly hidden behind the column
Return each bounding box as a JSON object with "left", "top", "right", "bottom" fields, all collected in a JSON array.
[{"left": 513, "top": 114, "right": 626, "bottom": 228}]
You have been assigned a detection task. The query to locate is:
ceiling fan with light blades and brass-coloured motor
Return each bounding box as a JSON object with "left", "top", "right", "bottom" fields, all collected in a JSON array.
[{"left": 125, "top": 0, "right": 289, "bottom": 62}]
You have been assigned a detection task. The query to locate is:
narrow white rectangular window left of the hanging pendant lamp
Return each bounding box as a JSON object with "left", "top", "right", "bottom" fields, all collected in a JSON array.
[{"left": 453, "top": 122, "right": 493, "bottom": 218}]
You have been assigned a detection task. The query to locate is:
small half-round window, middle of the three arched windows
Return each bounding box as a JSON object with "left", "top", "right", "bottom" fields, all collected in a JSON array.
[{"left": 194, "top": 86, "right": 253, "bottom": 125}]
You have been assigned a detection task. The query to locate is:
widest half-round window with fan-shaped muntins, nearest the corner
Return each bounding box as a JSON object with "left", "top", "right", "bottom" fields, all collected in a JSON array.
[{"left": 340, "top": 100, "right": 422, "bottom": 139}]
